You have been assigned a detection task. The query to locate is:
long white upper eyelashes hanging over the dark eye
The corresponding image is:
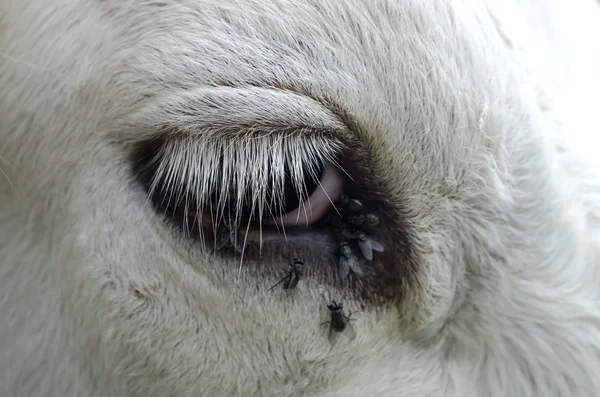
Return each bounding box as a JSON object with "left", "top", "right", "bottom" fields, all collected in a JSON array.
[{"left": 148, "top": 129, "right": 344, "bottom": 246}]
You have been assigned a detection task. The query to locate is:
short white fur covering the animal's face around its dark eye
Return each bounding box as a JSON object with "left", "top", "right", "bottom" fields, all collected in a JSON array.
[{"left": 0, "top": 0, "right": 600, "bottom": 397}]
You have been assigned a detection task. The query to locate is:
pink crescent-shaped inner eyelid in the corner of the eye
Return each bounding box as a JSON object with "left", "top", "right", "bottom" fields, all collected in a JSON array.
[{"left": 274, "top": 165, "right": 344, "bottom": 226}]
